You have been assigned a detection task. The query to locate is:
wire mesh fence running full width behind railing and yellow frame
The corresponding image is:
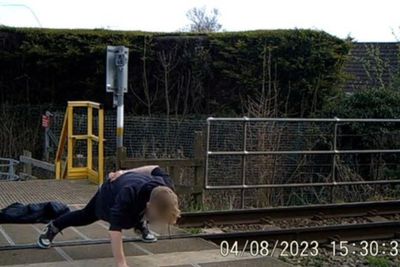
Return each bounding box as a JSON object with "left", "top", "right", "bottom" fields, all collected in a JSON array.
[{"left": 0, "top": 104, "right": 400, "bottom": 209}]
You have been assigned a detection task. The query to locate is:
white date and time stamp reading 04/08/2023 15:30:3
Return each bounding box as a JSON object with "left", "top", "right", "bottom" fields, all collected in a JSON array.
[{"left": 220, "top": 240, "right": 400, "bottom": 257}]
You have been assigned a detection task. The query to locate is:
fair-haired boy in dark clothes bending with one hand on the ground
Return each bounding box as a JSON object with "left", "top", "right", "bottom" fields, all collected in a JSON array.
[{"left": 38, "top": 165, "right": 180, "bottom": 267}]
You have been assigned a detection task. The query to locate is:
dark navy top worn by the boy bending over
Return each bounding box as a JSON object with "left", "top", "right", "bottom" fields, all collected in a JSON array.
[{"left": 96, "top": 168, "right": 174, "bottom": 231}]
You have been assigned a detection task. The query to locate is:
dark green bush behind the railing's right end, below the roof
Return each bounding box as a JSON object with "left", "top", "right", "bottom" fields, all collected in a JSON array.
[{"left": 326, "top": 88, "right": 400, "bottom": 182}]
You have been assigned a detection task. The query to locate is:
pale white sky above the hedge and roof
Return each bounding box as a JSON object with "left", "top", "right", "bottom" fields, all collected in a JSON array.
[{"left": 0, "top": 0, "right": 400, "bottom": 42}]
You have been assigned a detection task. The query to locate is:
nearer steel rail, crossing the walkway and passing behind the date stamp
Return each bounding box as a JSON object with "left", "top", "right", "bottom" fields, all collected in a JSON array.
[{"left": 0, "top": 221, "right": 400, "bottom": 251}]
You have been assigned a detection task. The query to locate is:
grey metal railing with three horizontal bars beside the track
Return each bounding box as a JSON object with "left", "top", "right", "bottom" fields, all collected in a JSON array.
[{"left": 204, "top": 117, "right": 400, "bottom": 207}]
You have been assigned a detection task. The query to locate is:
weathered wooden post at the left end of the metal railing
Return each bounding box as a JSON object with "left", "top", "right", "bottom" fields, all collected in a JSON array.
[{"left": 193, "top": 131, "right": 205, "bottom": 207}]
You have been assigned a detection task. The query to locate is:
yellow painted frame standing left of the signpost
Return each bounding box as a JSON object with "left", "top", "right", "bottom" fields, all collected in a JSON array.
[{"left": 55, "top": 101, "right": 104, "bottom": 184}]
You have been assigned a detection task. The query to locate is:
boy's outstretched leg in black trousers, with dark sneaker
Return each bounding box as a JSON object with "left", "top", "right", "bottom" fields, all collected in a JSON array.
[{"left": 38, "top": 193, "right": 98, "bottom": 248}]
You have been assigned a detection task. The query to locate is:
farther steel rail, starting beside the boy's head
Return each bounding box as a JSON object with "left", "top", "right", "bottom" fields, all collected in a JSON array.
[{"left": 178, "top": 200, "right": 400, "bottom": 227}]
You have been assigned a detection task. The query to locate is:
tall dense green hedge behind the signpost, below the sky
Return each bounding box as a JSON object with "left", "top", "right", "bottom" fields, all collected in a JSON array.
[{"left": 0, "top": 28, "right": 349, "bottom": 116}]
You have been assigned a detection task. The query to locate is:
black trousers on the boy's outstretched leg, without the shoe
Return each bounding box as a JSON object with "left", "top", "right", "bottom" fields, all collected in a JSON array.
[{"left": 53, "top": 191, "right": 100, "bottom": 231}]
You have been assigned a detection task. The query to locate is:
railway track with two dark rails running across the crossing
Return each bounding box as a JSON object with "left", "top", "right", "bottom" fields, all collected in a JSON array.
[{"left": 0, "top": 201, "right": 400, "bottom": 251}]
